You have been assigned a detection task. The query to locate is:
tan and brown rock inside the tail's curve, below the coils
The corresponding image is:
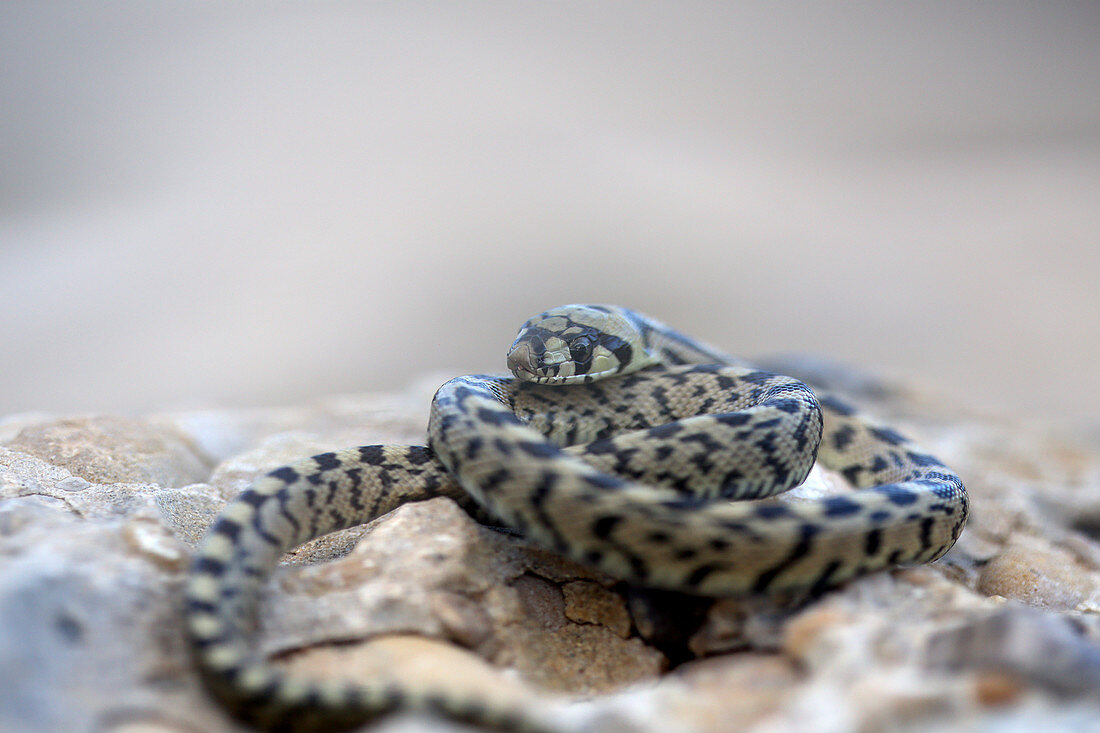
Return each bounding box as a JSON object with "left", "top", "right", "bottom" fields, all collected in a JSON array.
[{"left": 253, "top": 499, "right": 664, "bottom": 694}]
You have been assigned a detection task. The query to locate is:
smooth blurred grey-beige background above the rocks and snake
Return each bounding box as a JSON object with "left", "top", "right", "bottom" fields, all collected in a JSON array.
[{"left": 0, "top": 1, "right": 1100, "bottom": 425}]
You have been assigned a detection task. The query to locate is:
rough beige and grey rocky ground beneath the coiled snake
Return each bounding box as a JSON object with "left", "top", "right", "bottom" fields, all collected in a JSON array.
[{"left": 0, "top": 360, "right": 1100, "bottom": 733}]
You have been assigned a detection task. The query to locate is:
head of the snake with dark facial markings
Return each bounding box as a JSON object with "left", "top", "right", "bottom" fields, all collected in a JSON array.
[{"left": 508, "top": 305, "right": 655, "bottom": 384}]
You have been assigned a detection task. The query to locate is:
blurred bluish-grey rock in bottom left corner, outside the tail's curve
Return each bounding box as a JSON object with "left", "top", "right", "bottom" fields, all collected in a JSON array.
[{"left": 0, "top": 508, "right": 227, "bottom": 732}]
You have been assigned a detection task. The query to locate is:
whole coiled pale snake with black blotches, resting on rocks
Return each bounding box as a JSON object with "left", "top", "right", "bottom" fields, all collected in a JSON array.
[{"left": 185, "top": 305, "right": 969, "bottom": 733}]
